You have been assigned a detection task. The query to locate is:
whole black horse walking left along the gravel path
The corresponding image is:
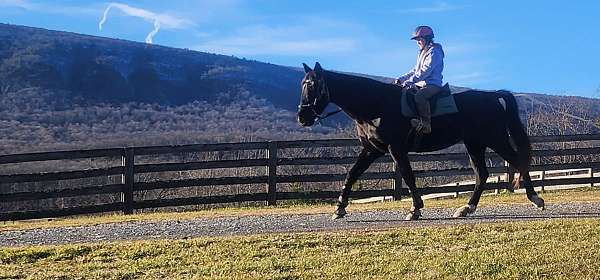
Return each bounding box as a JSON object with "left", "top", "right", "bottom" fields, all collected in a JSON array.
[{"left": 298, "top": 63, "right": 544, "bottom": 220}]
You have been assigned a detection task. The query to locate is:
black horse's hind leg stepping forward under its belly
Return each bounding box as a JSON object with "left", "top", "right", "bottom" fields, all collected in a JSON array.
[{"left": 453, "top": 143, "right": 490, "bottom": 218}]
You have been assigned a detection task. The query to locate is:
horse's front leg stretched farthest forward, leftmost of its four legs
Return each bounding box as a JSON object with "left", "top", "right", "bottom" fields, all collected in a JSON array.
[{"left": 332, "top": 147, "right": 384, "bottom": 220}]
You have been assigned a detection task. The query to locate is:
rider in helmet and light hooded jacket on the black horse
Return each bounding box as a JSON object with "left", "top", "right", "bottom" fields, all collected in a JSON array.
[{"left": 394, "top": 26, "right": 444, "bottom": 133}]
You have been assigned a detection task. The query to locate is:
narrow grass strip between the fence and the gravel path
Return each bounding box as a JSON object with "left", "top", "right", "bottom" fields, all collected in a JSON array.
[{"left": 0, "top": 188, "right": 600, "bottom": 232}]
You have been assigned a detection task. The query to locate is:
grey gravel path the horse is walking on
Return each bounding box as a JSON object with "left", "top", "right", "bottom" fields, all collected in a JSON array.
[{"left": 0, "top": 202, "right": 600, "bottom": 247}]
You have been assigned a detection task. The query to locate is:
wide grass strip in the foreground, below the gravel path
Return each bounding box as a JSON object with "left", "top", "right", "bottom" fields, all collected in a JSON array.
[{"left": 0, "top": 219, "right": 600, "bottom": 279}]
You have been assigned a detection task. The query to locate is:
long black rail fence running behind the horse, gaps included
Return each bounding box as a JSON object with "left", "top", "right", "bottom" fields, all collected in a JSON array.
[{"left": 0, "top": 135, "right": 600, "bottom": 221}]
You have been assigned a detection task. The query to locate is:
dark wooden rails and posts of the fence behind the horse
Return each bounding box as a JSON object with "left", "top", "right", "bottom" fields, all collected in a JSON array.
[{"left": 0, "top": 135, "right": 600, "bottom": 221}]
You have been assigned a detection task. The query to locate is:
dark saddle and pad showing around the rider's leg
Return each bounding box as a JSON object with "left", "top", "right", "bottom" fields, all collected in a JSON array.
[{"left": 401, "top": 83, "right": 458, "bottom": 118}]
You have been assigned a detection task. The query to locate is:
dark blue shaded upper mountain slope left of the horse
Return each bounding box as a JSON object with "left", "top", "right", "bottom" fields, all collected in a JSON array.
[{"left": 0, "top": 24, "right": 302, "bottom": 109}]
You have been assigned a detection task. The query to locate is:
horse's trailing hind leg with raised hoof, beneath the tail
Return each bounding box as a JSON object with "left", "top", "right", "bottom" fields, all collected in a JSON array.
[{"left": 491, "top": 139, "right": 545, "bottom": 210}]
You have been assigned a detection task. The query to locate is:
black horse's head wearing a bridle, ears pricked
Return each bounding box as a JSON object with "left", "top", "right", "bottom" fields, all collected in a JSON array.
[{"left": 298, "top": 62, "right": 330, "bottom": 126}]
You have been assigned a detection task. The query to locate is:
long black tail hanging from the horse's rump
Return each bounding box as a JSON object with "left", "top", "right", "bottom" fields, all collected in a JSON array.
[{"left": 498, "top": 90, "right": 531, "bottom": 188}]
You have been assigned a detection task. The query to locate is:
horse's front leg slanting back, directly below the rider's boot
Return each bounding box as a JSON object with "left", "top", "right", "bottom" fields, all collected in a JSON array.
[{"left": 389, "top": 146, "right": 424, "bottom": 221}]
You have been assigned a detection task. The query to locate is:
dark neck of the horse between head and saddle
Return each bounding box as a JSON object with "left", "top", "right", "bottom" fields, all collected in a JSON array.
[{"left": 327, "top": 72, "right": 385, "bottom": 121}]
